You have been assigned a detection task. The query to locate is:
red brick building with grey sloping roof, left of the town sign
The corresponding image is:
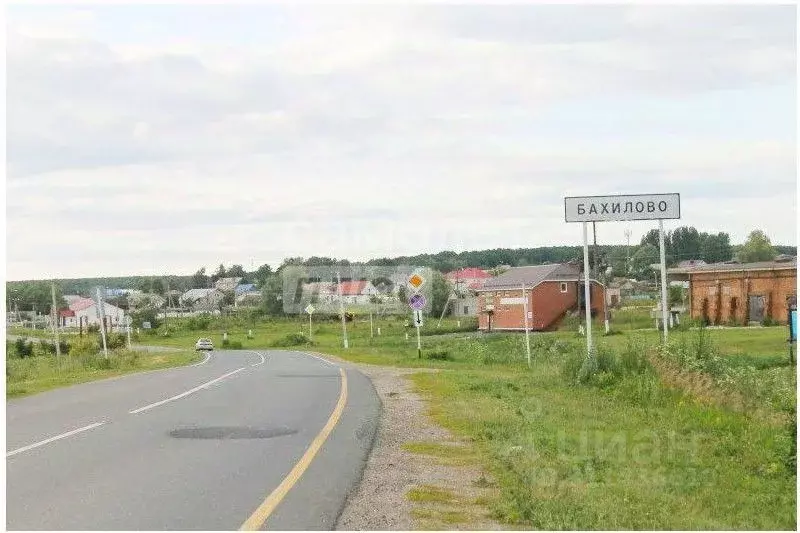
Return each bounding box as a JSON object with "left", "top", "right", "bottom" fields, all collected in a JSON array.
[{"left": 477, "top": 264, "right": 605, "bottom": 331}]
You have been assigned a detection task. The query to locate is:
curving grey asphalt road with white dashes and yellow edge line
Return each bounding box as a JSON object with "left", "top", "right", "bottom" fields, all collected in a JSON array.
[{"left": 6, "top": 351, "right": 380, "bottom": 530}]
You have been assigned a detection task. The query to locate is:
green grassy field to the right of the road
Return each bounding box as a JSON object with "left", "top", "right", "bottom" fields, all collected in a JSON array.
[{"left": 7, "top": 316, "right": 796, "bottom": 530}]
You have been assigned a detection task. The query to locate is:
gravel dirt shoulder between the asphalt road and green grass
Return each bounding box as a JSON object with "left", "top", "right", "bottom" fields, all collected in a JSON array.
[{"left": 331, "top": 357, "right": 504, "bottom": 531}]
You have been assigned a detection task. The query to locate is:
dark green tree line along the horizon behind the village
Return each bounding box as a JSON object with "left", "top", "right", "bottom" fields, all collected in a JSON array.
[{"left": 6, "top": 226, "right": 797, "bottom": 313}]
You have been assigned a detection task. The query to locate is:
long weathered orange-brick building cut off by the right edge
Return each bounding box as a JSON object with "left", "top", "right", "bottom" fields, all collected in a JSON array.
[{"left": 667, "top": 257, "right": 797, "bottom": 325}]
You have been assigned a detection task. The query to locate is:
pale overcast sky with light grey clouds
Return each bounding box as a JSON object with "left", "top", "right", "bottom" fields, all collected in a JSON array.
[{"left": 6, "top": 5, "right": 797, "bottom": 279}]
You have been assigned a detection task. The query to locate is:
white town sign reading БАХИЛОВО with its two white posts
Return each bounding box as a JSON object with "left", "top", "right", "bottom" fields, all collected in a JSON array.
[{"left": 564, "top": 193, "right": 681, "bottom": 356}]
